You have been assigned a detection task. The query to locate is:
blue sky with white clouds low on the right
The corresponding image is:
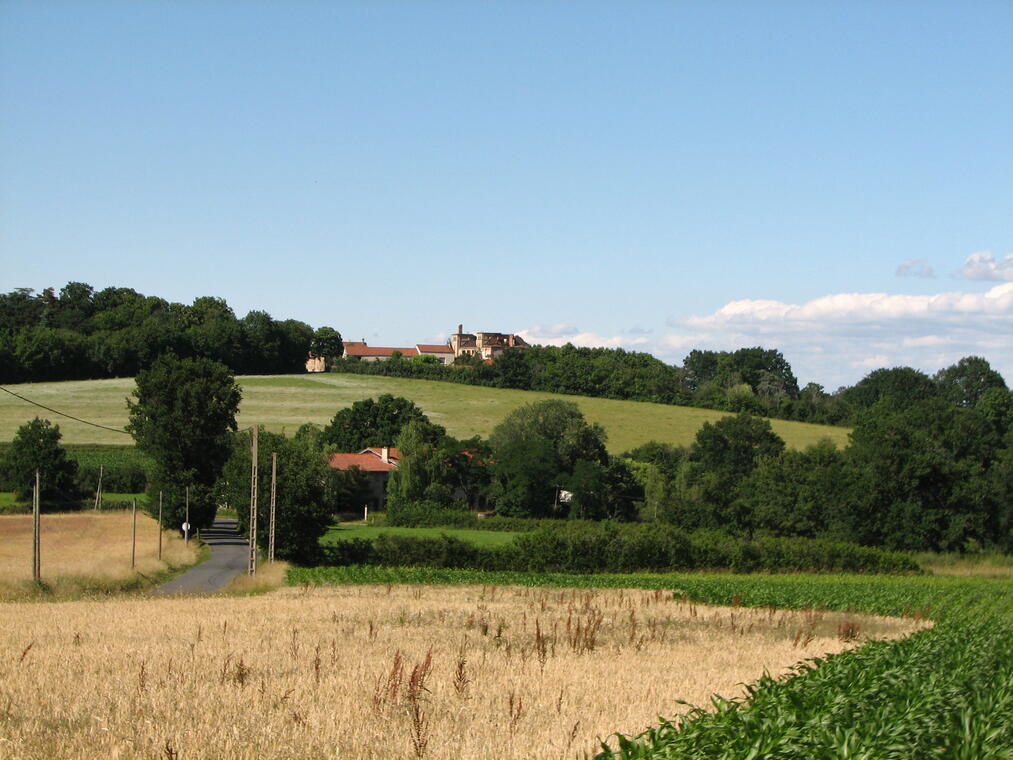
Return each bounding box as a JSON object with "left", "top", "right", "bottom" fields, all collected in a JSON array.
[{"left": 0, "top": 0, "right": 1013, "bottom": 389}]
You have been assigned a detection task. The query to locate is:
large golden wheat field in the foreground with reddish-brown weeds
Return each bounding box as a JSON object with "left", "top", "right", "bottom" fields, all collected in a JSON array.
[{"left": 0, "top": 586, "right": 918, "bottom": 760}]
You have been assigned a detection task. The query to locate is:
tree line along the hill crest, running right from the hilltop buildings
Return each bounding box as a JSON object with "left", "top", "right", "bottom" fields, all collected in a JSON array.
[{"left": 330, "top": 345, "right": 1006, "bottom": 426}]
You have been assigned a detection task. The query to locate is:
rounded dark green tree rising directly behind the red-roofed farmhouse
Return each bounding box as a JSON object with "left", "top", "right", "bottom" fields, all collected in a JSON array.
[{"left": 323, "top": 393, "right": 446, "bottom": 451}]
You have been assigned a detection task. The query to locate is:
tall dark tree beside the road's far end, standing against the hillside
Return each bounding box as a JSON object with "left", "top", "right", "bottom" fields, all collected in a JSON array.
[{"left": 127, "top": 354, "right": 241, "bottom": 528}]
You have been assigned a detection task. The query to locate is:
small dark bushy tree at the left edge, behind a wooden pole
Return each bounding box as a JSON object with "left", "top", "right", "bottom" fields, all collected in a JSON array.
[{"left": 0, "top": 416, "right": 80, "bottom": 503}]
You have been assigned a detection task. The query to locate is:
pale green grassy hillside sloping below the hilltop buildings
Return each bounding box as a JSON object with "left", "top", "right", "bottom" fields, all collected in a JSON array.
[{"left": 0, "top": 374, "right": 849, "bottom": 452}]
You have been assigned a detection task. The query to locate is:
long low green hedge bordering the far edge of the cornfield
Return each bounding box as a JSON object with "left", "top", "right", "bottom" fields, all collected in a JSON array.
[{"left": 323, "top": 522, "right": 919, "bottom": 574}]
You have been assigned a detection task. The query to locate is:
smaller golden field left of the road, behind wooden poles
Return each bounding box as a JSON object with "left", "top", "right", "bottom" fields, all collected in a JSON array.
[{"left": 0, "top": 510, "right": 197, "bottom": 599}]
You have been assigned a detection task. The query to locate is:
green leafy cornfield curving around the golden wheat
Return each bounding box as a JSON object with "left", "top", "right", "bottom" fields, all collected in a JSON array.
[{"left": 290, "top": 567, "right": 1013, "bottom": 760}]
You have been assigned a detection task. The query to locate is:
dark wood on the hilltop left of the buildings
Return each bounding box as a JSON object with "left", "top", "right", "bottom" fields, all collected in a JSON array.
[{"left": 0, "top": 283, "right": 343, "bottom": 383}]
